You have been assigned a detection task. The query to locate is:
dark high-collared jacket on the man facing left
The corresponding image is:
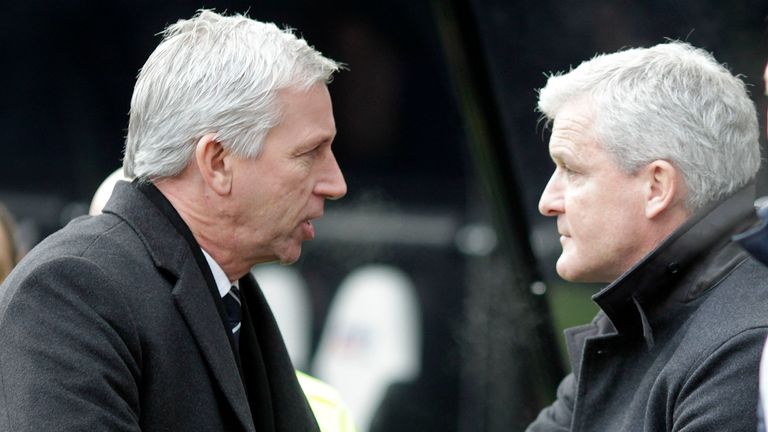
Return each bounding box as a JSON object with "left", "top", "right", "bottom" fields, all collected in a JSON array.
[{"left": 528, "top": 186, "right": 768, "bottom": 432}]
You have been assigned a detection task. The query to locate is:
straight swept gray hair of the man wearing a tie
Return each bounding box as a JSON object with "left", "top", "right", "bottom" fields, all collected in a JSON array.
[{"left": 123, "top": 10, "right": 341, "bottom": 180}]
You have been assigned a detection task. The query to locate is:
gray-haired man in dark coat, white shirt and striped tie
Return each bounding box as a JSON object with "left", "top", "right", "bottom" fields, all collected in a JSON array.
[{"left": 0, "top": 11, "right": 346, "bottom": 432}]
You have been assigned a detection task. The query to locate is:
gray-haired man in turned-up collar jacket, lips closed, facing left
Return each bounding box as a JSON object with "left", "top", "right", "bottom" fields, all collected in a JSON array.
[{"left": 528, "top": 42, "right": 768, "bottom": 432}]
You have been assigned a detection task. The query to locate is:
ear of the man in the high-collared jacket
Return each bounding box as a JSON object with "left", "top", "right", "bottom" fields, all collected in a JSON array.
[{"left": 643, "top": 159, "right": 684, "bottom": 219}]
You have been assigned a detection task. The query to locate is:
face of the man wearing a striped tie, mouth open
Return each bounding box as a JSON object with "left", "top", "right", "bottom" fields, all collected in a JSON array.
[{"left": 231, "top": 84, "right": 347, "bottom": 264}]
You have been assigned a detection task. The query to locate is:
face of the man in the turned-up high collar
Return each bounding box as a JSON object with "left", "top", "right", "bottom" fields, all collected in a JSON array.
[{"left": 539, "top": 101, "right": 647, "bottom": 282}]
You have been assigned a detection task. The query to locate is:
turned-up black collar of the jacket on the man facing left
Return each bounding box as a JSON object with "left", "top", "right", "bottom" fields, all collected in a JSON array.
[{"left": 592, "top": 184, "right": 755, "bottom": 346}]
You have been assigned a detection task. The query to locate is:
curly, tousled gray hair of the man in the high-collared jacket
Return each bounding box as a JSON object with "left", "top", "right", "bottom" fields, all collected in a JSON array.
[{"left": 538, "top": 41, "right": 760, "bottom": 212}]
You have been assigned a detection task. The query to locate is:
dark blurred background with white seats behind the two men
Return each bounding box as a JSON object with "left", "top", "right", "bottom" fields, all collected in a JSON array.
[{"left": 0, "top": 0, "right": 768, "bottom": 432}]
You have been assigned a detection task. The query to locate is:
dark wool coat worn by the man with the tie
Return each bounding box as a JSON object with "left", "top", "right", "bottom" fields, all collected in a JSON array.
[{"left": 0, "top": 182, "right": 317, "bottom": 432}]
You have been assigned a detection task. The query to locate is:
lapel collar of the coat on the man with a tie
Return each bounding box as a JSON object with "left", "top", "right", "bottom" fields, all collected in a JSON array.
[{"left": 104, "top": 181, "right": 255, "bottom": 431}]
